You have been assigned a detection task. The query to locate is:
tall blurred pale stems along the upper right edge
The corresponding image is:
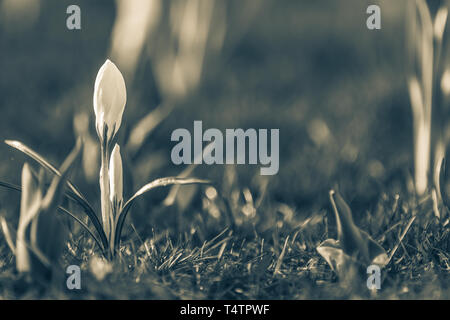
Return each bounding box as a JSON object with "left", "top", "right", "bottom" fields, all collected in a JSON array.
[{"left": 407, "top": 0, "right": 450, "bottom": 196}]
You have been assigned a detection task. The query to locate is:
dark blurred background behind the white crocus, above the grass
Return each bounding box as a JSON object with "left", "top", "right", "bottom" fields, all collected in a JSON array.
[{"left": 0, "top": 0, "right": 413, "bottom": 236}]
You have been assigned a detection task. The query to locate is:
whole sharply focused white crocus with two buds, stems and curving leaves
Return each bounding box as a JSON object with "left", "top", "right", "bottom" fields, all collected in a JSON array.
[{"left": 0, "top": 60, "right": 210, "bottom": 259}]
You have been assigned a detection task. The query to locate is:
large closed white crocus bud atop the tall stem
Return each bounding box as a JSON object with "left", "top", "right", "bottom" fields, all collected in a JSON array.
[{"left": 94, "top": 60, "right": 127, "bottom": 141}]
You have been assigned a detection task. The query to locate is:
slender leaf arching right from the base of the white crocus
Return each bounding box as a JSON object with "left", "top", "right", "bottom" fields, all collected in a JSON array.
[{"left": 114, "top": 177, "right": 211, "bottom": 249}]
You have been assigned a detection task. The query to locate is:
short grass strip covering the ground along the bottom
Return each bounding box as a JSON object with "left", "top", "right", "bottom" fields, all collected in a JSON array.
[{"left": 0, "top": 174, "right": 450, "bottom": 299}]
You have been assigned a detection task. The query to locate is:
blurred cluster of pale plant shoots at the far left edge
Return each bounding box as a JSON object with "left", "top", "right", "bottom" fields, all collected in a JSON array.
[{"left": 1, "top": 142, "right": 81, "bottom": 280}]
